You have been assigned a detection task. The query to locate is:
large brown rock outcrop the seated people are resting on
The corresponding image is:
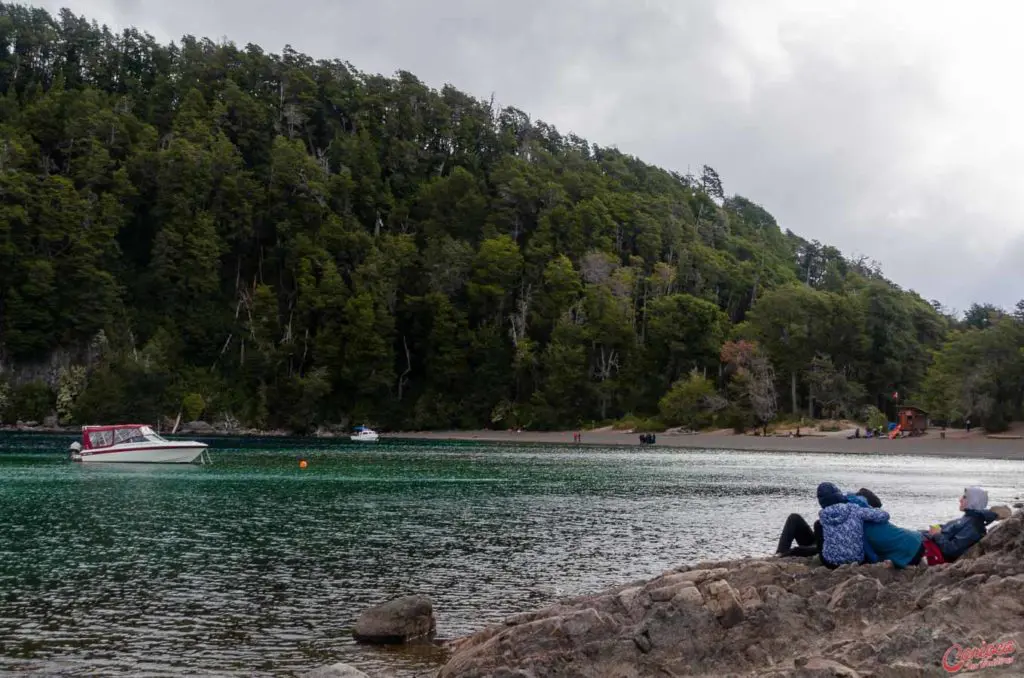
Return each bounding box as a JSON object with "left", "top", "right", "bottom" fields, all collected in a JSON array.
[{"left": 439, "top": 511, "right": 1024, "bottom": 678}]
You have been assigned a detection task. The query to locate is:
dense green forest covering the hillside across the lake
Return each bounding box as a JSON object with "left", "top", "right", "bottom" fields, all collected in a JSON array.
[{"left": 0, "top": 4, "right": 1024, "bottom": 431}]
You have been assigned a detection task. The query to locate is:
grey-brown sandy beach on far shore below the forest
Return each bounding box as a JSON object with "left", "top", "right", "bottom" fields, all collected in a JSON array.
[{"left": 386, "top": 429, "right": 1024, "bottom": 461}]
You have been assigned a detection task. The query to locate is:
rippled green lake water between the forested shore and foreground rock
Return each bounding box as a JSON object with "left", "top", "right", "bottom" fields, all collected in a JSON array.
[{"left": 0, "top": 434, "right": 1024, "bottom": 676}]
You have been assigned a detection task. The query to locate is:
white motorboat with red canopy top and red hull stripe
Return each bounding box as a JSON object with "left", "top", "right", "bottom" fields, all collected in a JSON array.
[{"left": 71, "top": 424, "right": 207, "bottom": 464}]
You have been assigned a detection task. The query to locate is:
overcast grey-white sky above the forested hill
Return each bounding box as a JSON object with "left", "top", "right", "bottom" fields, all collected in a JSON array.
[{"left": 37, "top": 0, "right": 1024, "bottom": 310}]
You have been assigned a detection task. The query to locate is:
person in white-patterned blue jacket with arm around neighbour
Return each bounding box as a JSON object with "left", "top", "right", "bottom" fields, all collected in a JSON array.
[{"left": 818, "top": 482, "right": 889, "bottom": 567}]
